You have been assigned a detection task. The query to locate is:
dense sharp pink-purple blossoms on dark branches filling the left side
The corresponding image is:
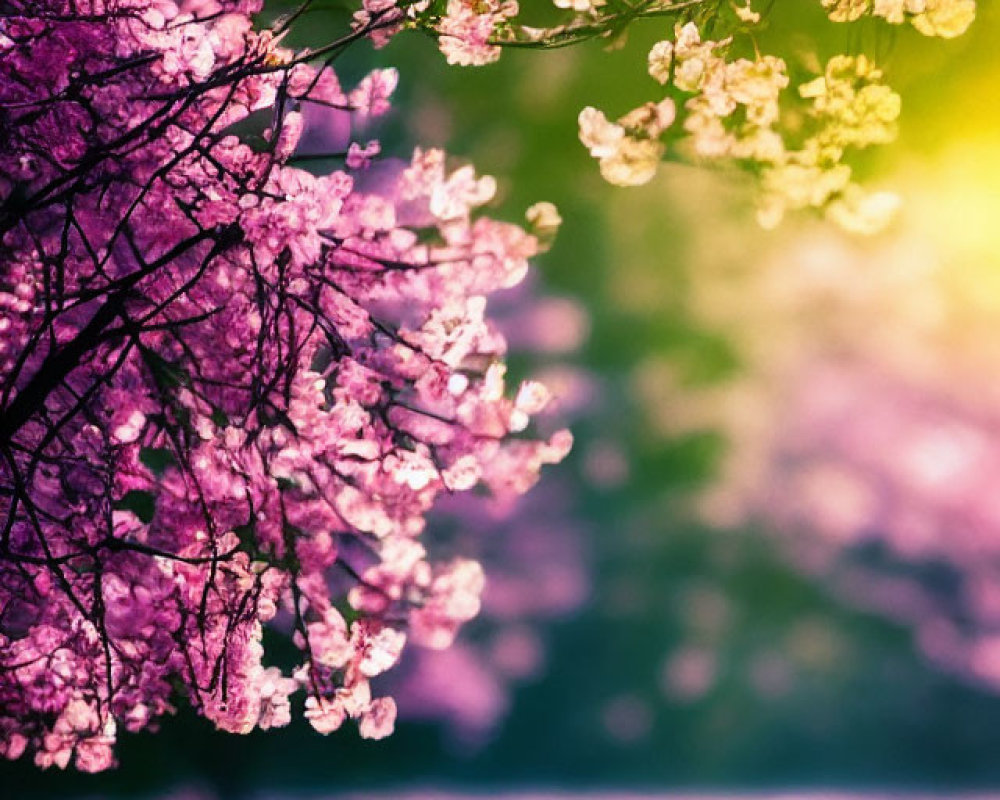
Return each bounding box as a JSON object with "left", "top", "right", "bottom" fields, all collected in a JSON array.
[{"left": 0, "top": 0, "right": 571, "bottom": 771}]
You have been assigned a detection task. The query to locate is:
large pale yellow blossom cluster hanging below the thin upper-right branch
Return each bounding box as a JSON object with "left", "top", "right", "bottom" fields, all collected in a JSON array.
[{"left": 580, "top": 12, "right": 916, "bottom": 232}]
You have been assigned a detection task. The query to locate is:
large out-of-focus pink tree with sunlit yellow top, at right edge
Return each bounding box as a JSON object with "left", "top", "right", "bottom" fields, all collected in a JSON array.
[{"left": 636, "top": 156, "right": 1000, "bottom": 691}]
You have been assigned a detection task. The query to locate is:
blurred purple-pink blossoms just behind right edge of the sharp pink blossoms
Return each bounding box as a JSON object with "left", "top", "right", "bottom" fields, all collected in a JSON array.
[{"left": 391, "top": 282, "right": 601, "bottom": 749}]
